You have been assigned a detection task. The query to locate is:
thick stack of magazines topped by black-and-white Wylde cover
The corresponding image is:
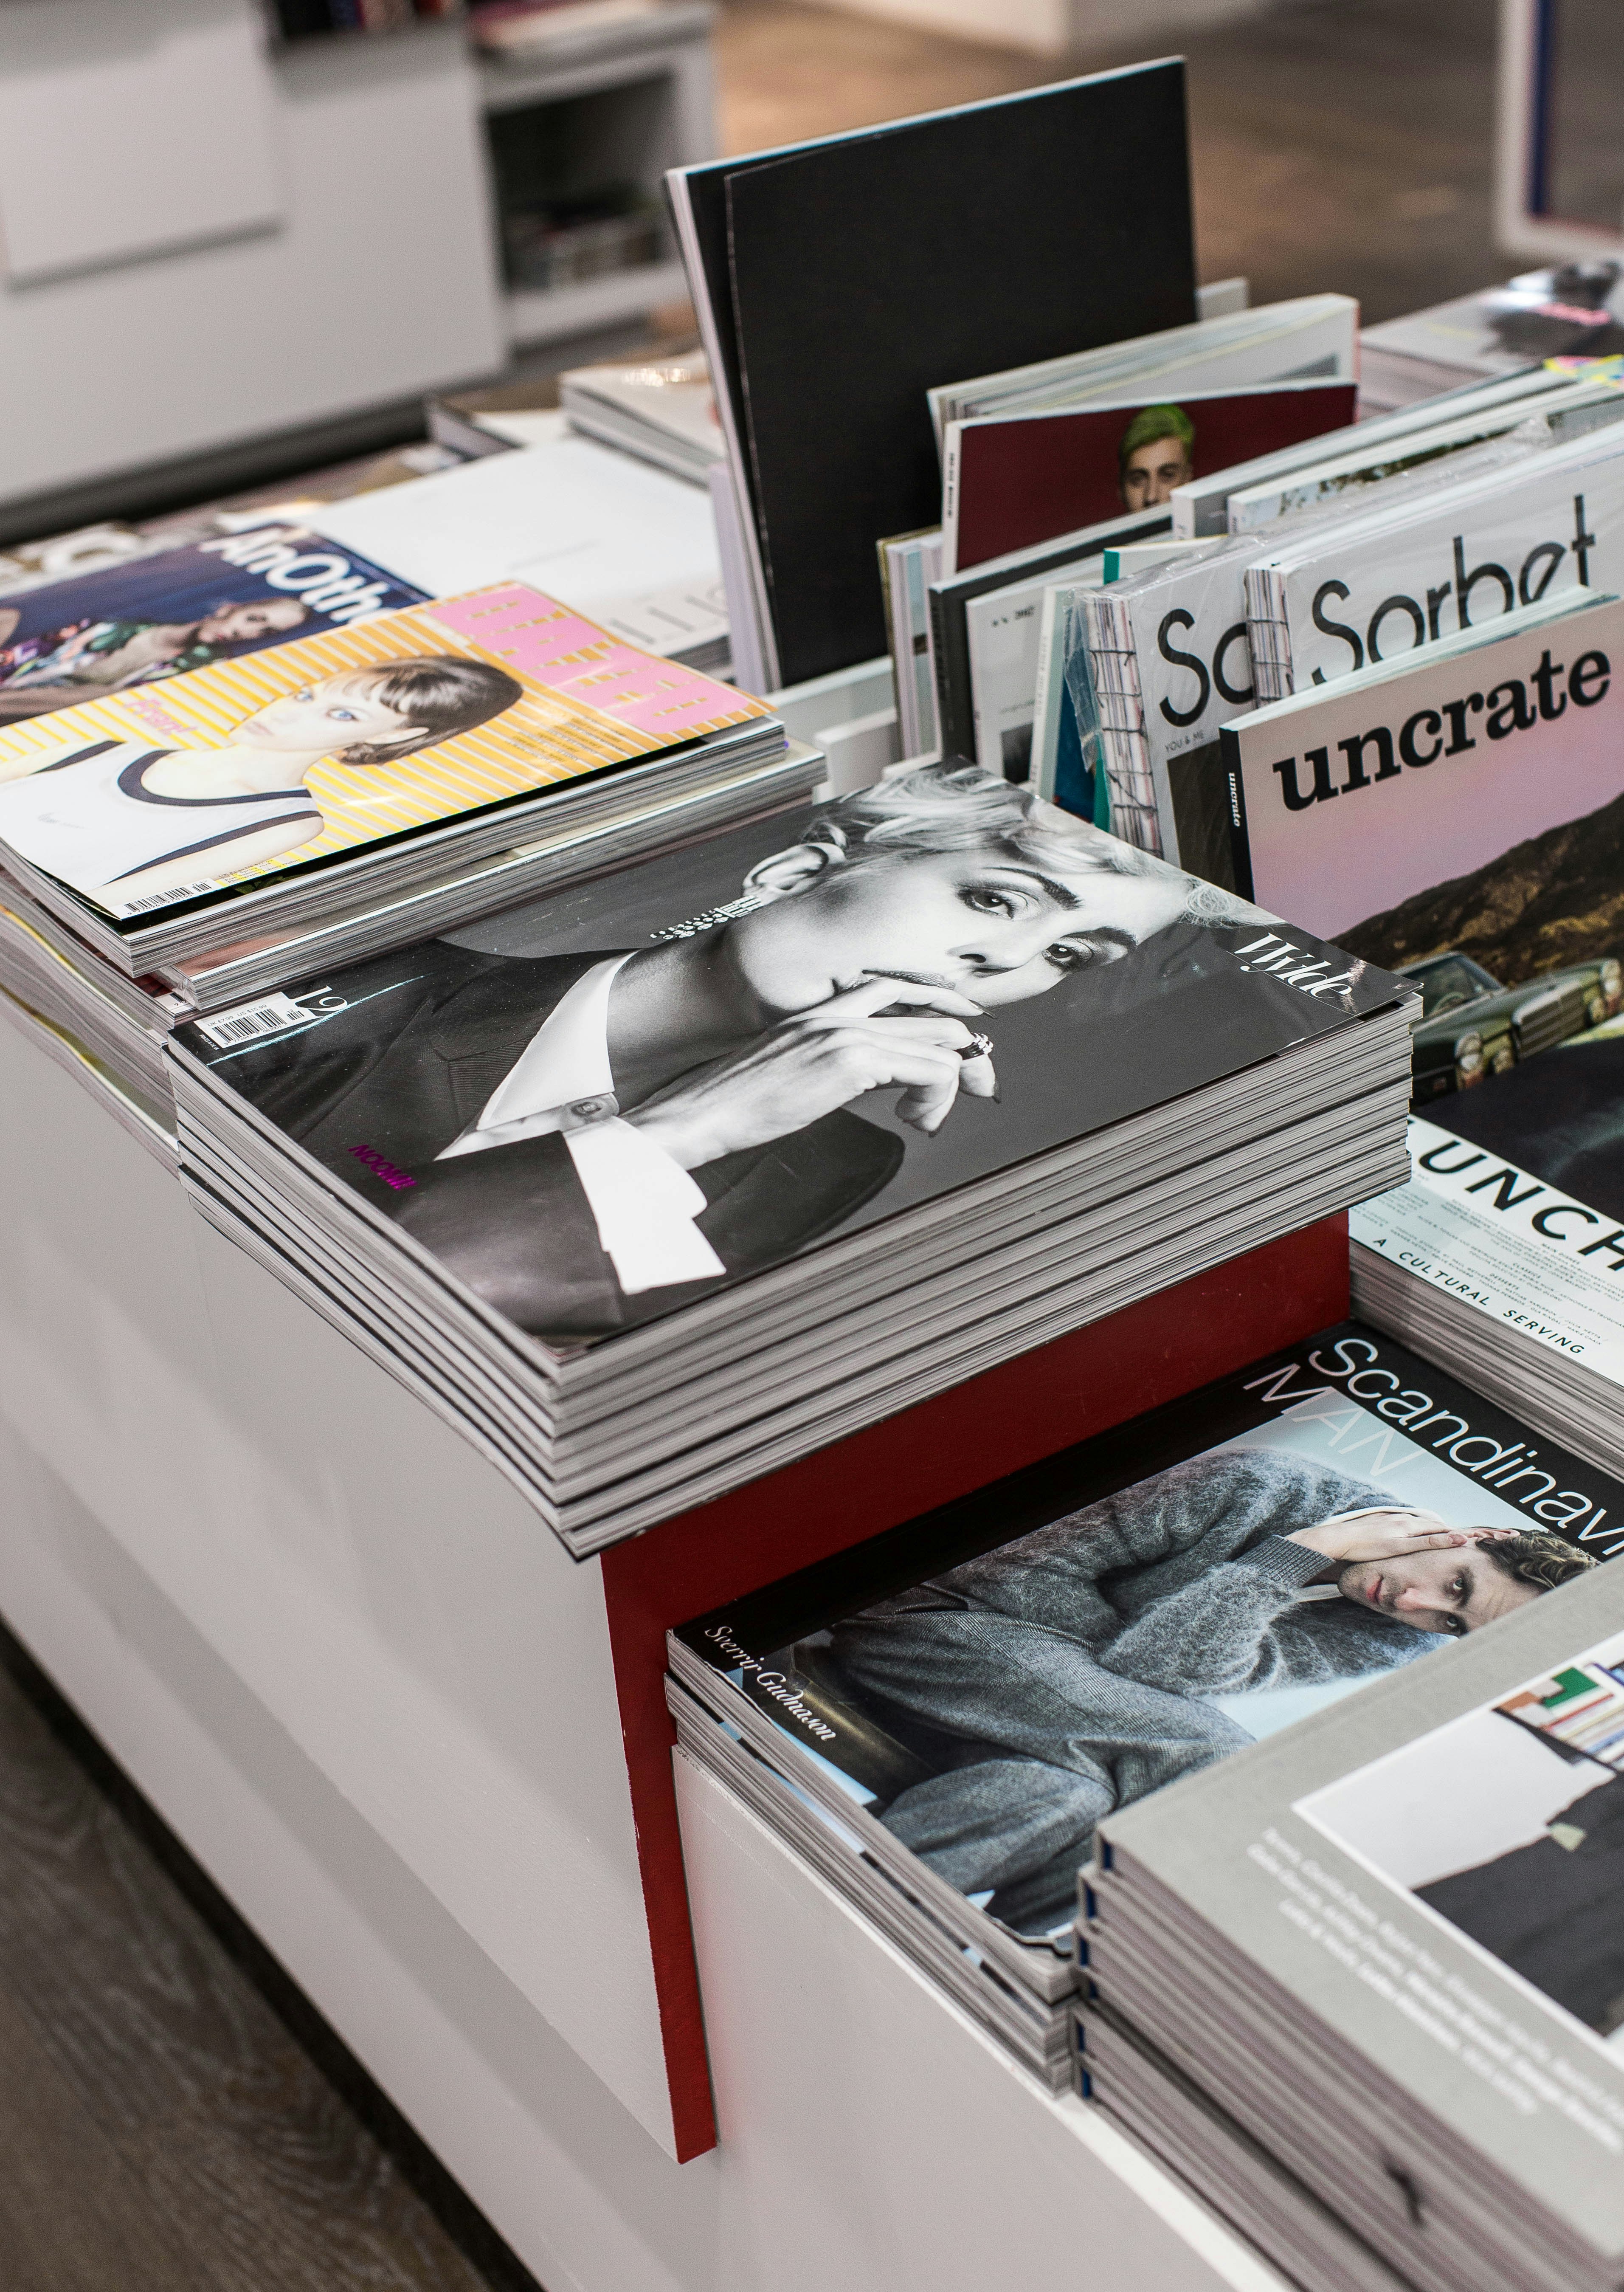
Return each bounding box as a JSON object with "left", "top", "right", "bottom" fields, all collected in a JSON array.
[{"left": 161, "top": 768, "right": 1413, "bottom": 1552}]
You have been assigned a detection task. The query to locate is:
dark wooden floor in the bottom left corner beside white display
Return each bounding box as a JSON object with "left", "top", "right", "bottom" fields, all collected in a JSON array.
[{"left": 0, "top": 1634, "right": 538, "bottom": 2292}]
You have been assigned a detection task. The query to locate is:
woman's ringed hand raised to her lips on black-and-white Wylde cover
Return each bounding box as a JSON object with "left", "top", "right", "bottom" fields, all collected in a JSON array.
[{"left": 625, "top": 979, "right": 999, "bottom": 1169}]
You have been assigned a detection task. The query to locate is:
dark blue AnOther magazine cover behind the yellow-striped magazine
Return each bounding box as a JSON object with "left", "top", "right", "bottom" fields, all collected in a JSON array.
[{"left": 0, "top": 525, "right": 422, "bottom": 724}]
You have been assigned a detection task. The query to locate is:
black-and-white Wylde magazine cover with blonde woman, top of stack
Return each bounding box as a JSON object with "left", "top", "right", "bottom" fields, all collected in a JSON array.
[{"left": 181, "top": 766, "right": 1393, "bottom": 1341}]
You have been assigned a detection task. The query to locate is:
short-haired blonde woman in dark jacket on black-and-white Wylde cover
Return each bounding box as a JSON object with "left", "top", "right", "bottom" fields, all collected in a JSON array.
[{"left": 193, "top": 766, "right": 1255, "bottom": 1341}]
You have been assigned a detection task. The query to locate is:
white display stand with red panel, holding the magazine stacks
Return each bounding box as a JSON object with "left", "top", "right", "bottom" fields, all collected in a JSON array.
[{"left": 0, "top": 1020, "right": 1347, "bottom": 2292}]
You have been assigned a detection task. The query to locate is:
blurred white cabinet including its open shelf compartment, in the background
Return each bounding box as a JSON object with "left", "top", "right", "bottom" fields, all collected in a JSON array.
[{"left": 0, "top": 0, "right": 715, "bottom": 543}]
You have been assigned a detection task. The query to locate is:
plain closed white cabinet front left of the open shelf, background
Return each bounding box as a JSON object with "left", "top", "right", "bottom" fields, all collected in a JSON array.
[{"left": 0, "top": 0, "right": 506, "bottom": 538}]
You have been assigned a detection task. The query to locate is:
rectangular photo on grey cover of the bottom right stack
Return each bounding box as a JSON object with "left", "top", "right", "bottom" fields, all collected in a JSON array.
[{"left": 1294, "top": 1634, "right": 1624, "bottom": 2054}]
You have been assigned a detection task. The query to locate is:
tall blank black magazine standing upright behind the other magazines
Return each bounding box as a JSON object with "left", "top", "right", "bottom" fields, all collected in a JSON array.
[{"left": 671, "top": 62, "right": 1196, "bottom": 685}]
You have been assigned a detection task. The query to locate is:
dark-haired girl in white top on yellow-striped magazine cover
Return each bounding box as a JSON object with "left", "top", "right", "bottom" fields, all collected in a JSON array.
[{"left": 0, "top": 653, "right": 524, "bottom": 914}]
